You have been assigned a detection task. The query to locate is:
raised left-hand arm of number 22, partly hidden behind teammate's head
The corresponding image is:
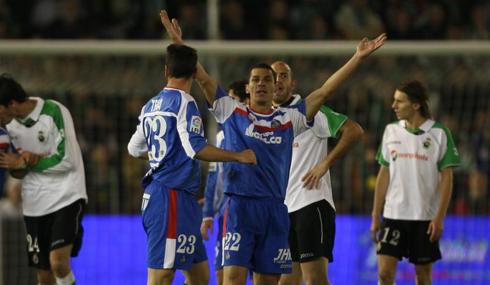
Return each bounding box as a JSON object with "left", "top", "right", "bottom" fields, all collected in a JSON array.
[{"left": 160, "top": 10, "right": 218, "bottom": 105}]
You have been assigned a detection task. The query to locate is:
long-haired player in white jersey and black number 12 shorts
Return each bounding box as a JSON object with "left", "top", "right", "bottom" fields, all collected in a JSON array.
[{"left": 371, "top": 81, "right": 460, "bottom": 285}]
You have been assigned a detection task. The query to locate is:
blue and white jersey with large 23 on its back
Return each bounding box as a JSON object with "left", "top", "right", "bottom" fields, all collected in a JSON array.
[{"left": 128, "top": 88, "right": 207, "bottom": 194}]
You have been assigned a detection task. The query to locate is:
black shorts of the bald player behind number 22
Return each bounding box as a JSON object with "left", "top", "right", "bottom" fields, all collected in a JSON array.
[{"left": 289, "top": 197, "right": 335, "bottom": 262}]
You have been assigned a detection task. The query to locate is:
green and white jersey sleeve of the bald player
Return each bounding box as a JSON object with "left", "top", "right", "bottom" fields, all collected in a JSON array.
[{"left": 311, "top": 106, "right": 347, "bottom": 138}]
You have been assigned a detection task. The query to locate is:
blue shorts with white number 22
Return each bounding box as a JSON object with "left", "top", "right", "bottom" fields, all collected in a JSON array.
[{"left": 223, "top": 195, "right": 292, "bottom": 274}]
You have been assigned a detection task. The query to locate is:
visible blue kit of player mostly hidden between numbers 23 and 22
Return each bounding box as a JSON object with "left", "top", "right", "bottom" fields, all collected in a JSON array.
[{"left": 203, "top": 131, "right": 225, "bottom": 270}]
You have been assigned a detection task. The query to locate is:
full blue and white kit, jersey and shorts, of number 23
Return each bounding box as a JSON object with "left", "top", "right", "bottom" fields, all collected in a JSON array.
[{"left": 128, "top": 88, "right": 207, "bottom": 270}]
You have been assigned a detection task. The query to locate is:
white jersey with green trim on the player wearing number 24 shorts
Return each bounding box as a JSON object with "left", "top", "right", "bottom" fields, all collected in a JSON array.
[{"left": 7, "top": 97, "right": 87, "bottom": 217}]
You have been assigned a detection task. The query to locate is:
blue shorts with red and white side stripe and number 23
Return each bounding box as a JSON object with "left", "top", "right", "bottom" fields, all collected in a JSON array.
[{"left": 142, "top": 180, "right": 207, "bottom": 270}]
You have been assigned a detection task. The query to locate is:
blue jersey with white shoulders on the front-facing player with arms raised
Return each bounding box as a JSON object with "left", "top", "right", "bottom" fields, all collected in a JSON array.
[{"left": 211, "top": 85, "right": 309, "bottom": 200}]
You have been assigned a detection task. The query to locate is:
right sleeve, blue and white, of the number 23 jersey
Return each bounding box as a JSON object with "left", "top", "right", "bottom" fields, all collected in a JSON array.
[{"left": 177, "top": 97, "right": 207, "bottom": 158}]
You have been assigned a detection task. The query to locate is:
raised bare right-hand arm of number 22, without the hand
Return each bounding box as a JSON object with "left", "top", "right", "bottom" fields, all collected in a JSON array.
[{"left": 305, "top": 53, "right": 362, "bottom": 120}]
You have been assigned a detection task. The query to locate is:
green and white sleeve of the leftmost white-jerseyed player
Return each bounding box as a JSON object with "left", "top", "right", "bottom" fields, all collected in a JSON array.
[{"left": 31, "top": 100, "right": 76, "bottom": 173}]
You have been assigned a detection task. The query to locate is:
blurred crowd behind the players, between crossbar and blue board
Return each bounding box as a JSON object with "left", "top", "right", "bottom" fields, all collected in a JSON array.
[{"left": 0, "top": 52, "right": 490, "bottom": 214}]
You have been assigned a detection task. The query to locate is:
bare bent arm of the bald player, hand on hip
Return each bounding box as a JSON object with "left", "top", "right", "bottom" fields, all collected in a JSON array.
[{"left": 301, "top": 119, "right": 364, "bottom": 189}]
